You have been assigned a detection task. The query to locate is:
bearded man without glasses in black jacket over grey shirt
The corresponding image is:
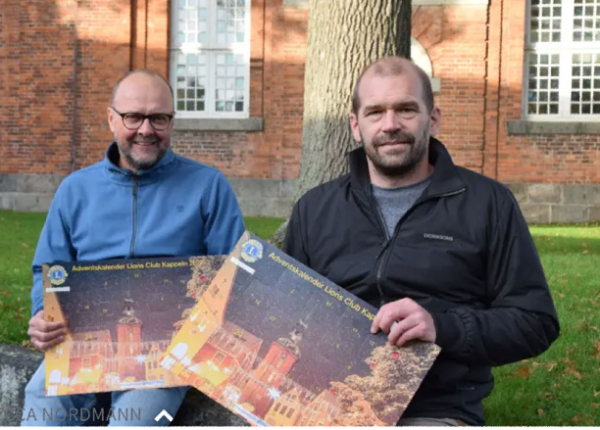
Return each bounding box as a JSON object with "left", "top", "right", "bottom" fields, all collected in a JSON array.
[{"left": 284, "top": 57, "right": 559, "bottom": 427}]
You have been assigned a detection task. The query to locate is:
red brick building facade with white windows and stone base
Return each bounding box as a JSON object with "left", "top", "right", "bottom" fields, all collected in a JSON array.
[{"left": 0, "top": 0, "right": 600, "bottom": 222}]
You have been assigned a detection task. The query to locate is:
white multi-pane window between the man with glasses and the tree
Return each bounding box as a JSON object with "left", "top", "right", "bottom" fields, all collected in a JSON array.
[{"left": 170, "top": 0, "right": 250, "bottom": 118}]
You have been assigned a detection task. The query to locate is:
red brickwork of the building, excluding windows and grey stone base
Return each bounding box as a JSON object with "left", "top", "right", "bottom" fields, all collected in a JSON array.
[{"left": 0, "top": 0, "right": 600, "bottom": 183}]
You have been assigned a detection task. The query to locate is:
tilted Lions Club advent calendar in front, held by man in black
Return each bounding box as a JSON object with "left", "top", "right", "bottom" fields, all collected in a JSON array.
[{"left": 161, "top": 232, "right": 439, "bottom": 426}]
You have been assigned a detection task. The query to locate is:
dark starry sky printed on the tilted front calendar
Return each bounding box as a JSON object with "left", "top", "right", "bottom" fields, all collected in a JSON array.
[{"left": 225, "top": 242, "right": 387, "bottom": 394}]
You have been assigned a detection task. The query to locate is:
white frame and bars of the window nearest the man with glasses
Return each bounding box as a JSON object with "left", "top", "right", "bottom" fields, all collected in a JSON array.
[{"left": 169, "top": 0, "right": 251, "bottom": 119}]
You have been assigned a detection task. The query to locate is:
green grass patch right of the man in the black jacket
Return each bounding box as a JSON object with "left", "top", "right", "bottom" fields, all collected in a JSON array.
[{"left": 485, "top": 224, "right": 600, "bottom": 426}]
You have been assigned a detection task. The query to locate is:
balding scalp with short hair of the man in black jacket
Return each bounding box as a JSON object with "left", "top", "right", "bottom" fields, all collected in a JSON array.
[{"left": 352, "top": 57, "right": 433, "bottom": 115}]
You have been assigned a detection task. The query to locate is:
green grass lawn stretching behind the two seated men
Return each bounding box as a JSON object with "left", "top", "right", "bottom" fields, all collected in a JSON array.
[{"left": 0, "top": 211, "right": 600, "bottom": 426}]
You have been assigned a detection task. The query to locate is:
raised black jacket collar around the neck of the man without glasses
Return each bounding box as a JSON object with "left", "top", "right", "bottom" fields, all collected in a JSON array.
[{"left": 349, "top": 137, "right": 465, "bottom": 197}]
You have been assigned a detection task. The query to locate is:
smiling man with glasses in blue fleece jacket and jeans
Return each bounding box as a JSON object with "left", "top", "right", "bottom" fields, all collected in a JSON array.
[{"left": 22, "top": 70, "right": 244, "bottom": 426}]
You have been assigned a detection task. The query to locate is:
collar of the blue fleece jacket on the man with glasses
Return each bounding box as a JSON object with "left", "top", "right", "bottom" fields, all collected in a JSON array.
[{"left": 103, "top": 142, "right": 177, "bottom": 185}]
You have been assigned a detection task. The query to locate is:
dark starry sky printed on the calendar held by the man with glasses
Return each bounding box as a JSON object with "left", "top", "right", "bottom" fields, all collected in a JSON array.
[{"left": 51, "top": 258, "right": 195, "bottom": 342}]
